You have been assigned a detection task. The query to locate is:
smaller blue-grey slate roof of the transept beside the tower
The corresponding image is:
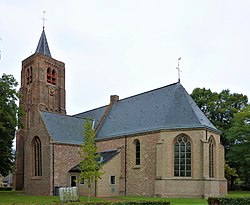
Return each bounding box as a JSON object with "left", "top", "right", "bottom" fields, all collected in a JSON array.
[{"left": 41, "top": 112, "right": 86, "bottom": 144}]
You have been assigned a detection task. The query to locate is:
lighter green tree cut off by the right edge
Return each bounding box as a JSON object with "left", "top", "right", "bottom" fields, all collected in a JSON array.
[{"left": 227, "top": 105, "right": 250, "bottom": 185}]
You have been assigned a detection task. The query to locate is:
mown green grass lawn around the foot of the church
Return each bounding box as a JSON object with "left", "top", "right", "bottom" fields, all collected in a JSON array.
[{"left": 0, "top": 191, "right": 250, "bottom": 205}]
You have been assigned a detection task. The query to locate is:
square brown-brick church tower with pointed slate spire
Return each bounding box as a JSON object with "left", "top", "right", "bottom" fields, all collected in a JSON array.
[{"left": 14, "top": 28, "right": 66, "bottom": 190}]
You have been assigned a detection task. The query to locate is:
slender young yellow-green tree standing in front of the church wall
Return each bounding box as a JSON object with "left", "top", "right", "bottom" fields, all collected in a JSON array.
[{"left": 79, "top": 119, "right": 103, "bottom": 200}]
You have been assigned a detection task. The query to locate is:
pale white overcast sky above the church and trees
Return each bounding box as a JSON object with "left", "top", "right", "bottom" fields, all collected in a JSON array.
[{"left": 0, "top": 0, "right": 250, "bottom": 114}]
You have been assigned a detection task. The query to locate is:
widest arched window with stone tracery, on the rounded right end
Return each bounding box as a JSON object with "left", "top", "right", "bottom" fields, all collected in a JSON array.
[{"left": 174, "top": 135, "right": 191, "bottom": 177}]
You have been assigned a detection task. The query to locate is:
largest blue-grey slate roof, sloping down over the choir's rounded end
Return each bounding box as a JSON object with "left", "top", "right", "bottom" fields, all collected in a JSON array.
[{"left": 94, "top": 83, "right": 219, "bottom": 139}]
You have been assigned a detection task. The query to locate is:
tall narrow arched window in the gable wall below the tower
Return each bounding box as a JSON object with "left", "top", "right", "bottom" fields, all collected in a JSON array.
[{"left": 32, "top": 136, "right": 42, "bottom": 176}]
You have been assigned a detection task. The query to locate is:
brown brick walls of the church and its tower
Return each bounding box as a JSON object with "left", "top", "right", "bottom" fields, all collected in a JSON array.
[{"left": 14, "top": 47, "right": 227, "bottom": 197}]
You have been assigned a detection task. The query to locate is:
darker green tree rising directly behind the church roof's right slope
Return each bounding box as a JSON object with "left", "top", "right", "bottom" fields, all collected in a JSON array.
[{"left": 191, "top": 88, "right": 248, "bottom": 147}]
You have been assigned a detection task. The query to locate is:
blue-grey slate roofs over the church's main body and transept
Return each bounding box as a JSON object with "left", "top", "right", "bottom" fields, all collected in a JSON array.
[{"left": 41, "top": 83, "right": 220, "bottom": 144}]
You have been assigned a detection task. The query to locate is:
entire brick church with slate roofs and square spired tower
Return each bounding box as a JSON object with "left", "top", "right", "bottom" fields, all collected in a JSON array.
[{"left": 14, "top": 28, "right": 227, "bottom": 198}]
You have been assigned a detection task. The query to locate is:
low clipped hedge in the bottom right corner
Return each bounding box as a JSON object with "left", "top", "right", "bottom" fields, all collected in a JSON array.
[{"left": 207, "top": 197, "right": 250, "bottom": 205}]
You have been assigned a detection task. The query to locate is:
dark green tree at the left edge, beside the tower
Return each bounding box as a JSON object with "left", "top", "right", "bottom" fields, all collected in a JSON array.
[{"left": 0, "top": 74, "right": 18, "bottom": 176}]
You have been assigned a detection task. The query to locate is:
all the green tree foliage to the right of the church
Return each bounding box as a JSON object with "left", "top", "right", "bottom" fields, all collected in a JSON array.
[{"left": 191, "top": 88, "right": 250, "bottom": 187}]
